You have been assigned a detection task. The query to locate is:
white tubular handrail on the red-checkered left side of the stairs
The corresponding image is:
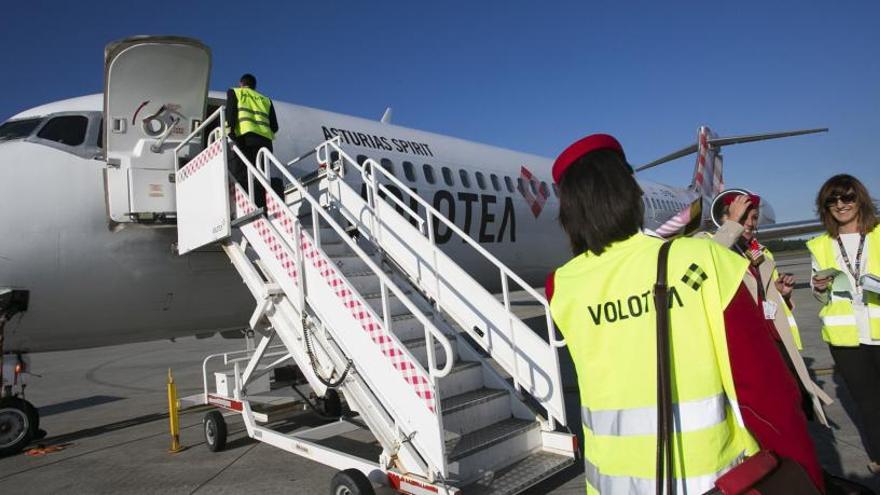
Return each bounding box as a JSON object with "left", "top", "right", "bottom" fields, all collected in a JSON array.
[{"left": 232, "top": 144, "right": 454, "bottom": 387}]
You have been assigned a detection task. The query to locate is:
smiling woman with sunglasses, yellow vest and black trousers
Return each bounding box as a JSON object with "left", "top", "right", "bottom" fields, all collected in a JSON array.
[{"left": 807, "top": 174, "right": 880, "bottom": 474}]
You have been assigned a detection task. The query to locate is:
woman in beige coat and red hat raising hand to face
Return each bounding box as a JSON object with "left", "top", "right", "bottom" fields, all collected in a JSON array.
[{"left": 697, "top": 189, "right": 832, "bottom": 426}]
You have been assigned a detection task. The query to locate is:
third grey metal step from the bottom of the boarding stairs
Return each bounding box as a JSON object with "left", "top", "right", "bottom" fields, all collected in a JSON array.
[{"left": 440, "top": 387, "right": 511, "bottom": 435}]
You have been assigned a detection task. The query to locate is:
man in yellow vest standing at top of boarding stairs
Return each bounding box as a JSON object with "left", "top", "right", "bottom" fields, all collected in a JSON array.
[{"left": 226, "top": 74, "right": 283, "bottom": 207}]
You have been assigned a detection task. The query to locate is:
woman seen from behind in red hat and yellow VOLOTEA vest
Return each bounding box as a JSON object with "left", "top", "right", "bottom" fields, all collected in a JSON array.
[{"left": 547, "top": 134, "right": 822, "bottom": 495}]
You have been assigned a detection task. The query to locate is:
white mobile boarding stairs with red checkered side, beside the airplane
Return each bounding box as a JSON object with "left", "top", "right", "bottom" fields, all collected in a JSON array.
[{"left": 176, "top": 107, "right": 576, "bottom": 494}]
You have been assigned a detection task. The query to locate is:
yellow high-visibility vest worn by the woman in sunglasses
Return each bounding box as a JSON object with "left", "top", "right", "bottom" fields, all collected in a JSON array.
[{"left": 807, "top": 227, "right": 880, "bottom": 347}]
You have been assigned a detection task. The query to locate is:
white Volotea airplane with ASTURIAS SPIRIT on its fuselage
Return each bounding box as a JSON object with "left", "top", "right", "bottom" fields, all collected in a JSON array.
[{"left": 0, "top": 37, "right": 822, "bottom": 454}]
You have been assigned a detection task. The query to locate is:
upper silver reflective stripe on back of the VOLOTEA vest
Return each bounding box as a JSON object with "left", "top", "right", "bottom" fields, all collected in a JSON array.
[{"left": 581, "top": 393, "right": 727, "bottom": 436}]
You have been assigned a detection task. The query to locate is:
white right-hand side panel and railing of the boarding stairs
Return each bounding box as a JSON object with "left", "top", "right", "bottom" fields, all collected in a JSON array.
[{"left": 317, "top": 139, "right": 566, "bottom": 430}]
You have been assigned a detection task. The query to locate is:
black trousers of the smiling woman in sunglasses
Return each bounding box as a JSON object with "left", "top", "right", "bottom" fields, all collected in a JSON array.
[{"left": 829, "top": 345, "right": 880, "bottom": 462}]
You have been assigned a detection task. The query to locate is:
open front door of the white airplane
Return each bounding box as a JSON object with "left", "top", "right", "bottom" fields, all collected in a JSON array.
[{"left": 104, "top": 36, "right": 211, "bottom": 223}]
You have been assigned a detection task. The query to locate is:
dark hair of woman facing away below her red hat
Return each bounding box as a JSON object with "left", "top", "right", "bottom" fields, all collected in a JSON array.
[{"left": 559, "top": 149, "right": 645, "bottom": 255}]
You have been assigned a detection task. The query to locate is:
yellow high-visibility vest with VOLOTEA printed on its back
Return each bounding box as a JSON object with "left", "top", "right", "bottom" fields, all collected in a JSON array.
[{"left": 550, "top": 233, "right": 758, "bottom": 494}]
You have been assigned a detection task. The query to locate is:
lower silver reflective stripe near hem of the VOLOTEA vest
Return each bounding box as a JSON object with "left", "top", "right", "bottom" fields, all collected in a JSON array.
[{"left": 584, "top": 452, "right": 745, "bottom": 495}]
